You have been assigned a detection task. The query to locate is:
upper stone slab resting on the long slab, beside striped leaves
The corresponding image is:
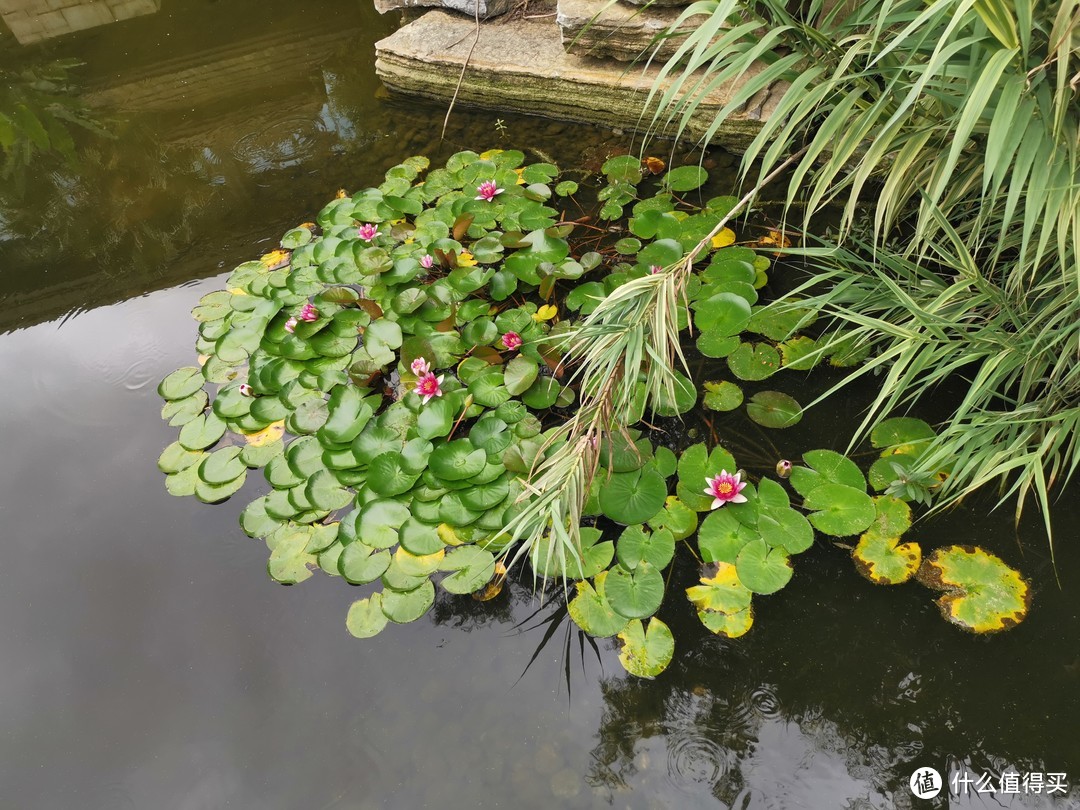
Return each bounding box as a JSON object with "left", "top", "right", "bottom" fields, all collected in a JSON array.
[{"left": 555, "top": 0, "right": 707, "bottom": 62}]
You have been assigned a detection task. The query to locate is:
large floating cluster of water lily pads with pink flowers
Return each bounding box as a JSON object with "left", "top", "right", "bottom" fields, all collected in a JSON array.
[{"left": 158, "top": 150, "right": 1028, "bottom": 676}]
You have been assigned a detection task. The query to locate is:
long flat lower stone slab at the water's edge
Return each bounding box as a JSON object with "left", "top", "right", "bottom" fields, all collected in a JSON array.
[{"left": 375, "top": 11, "right": 786, "bottom": 151}]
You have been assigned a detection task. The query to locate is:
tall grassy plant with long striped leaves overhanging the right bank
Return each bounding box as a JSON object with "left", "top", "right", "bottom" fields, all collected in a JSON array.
[{"left": 650, "top": 0, "right": 1080, "bottom": 548}]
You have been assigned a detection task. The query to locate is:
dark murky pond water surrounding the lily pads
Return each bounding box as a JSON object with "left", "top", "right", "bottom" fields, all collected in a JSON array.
[{"left": 0, "top": 0, "right": 1080, "bottom": 810}]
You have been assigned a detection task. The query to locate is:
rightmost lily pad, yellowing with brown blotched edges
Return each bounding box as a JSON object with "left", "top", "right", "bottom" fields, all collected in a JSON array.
[{"left": 918, "top": 545, "right": 1031, "bottom": 633}]
